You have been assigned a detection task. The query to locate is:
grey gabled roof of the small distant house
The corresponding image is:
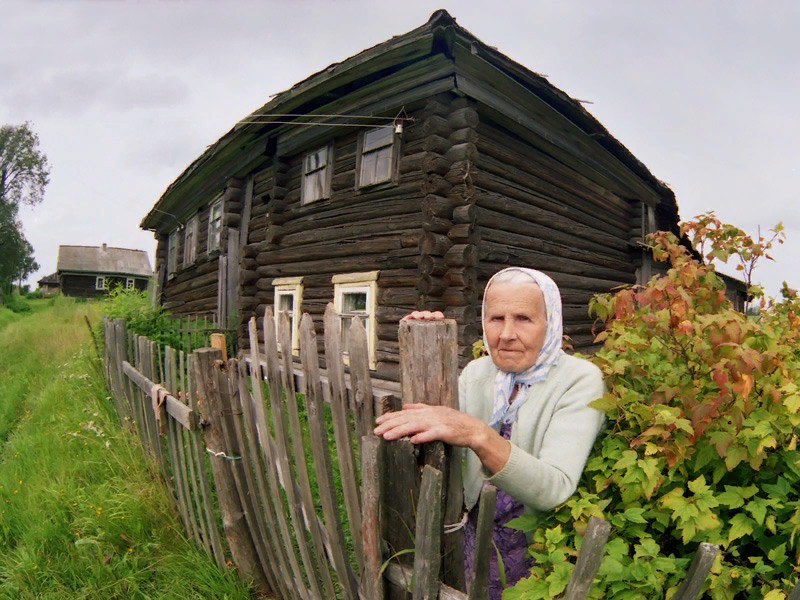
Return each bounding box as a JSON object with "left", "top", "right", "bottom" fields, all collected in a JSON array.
[{"left": 56, "top": 244, "right": 153, "bottom": 277}]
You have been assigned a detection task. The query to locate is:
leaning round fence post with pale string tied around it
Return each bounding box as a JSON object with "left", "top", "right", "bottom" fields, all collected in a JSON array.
[{"left": 192, "top": 348, "right": 268, "bottom": 590}]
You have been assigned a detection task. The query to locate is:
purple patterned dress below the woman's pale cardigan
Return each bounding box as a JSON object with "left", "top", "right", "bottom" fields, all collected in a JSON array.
[{"left": 464, "top": 423, "right": 533, "bottom": 600}]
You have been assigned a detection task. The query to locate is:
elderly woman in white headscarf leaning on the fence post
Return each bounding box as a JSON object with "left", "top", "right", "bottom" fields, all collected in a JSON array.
[{"left": 375, "top": 267, "right": 603, "bottom": 600}]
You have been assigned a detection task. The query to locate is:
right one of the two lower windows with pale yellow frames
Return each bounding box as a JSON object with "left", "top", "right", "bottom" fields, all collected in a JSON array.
[{"left": 331, "top": 271, "right": 378, "bottom": 369}]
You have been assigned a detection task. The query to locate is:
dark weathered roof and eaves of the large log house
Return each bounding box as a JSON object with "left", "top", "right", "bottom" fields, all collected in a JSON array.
[{"left": 140, "top": 10, "right": 678, "bottom": 230}]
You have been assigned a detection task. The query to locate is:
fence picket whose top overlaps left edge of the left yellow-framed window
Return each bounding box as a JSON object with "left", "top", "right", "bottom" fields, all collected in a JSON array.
[{"left": 264, "top": 310, "right": 323, "bottom": 598}]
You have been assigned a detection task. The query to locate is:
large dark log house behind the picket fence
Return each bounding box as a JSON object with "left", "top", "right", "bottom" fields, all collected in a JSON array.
[{"left": 141, "top": 11, "right": 678, "bottom": 379}]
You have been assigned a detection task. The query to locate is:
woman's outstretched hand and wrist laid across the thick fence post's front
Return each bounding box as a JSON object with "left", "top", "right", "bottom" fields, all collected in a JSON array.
[{"left": 374, "top": 404, "right": 511, "bottom": 474}]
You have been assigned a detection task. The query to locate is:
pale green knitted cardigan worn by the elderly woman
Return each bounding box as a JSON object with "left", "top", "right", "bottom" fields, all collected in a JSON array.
[{"left": 458, "top": 355, "right": 604, "bottom": 512}]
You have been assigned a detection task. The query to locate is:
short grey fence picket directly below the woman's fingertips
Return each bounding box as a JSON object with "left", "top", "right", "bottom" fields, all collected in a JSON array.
[{"left": 361, "top": 435, "right": 387, "bottom": 600}]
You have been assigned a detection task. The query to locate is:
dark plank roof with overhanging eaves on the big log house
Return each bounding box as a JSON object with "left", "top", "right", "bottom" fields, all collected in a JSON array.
[{"left": 141, "top": 10, "right": 677, "bottom": 230}]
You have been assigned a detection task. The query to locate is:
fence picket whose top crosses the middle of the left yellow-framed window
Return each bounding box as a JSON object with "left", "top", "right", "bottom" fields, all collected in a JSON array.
[{"left": 276, "top": 312, "right": 336, "bottom": 598}]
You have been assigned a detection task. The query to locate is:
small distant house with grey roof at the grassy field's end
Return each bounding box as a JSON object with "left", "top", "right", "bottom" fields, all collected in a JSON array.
[{"left": 56, "top": 244, "right": 153, "bottom": 297}]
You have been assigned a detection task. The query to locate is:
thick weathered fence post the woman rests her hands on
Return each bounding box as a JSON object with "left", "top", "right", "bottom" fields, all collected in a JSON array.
[{"left": 396, "top": 319, "right": 466, "bottom": 591}]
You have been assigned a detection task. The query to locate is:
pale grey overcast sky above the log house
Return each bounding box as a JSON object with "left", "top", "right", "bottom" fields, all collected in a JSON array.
[{"left": 0, "top": 0, "right": 800, "bottom": 294}]
